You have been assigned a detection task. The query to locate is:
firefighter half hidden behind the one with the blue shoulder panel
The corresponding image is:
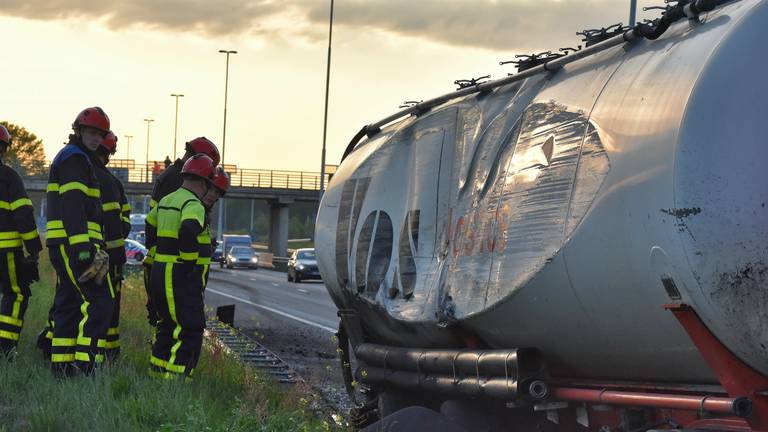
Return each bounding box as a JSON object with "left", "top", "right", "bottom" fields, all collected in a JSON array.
[{"left": 91, "top": 132, "right": 131, "bottom": 360}]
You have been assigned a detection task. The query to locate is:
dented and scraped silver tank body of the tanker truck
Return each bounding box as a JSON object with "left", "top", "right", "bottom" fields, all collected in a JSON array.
[{"left": 316, "top": 0, "right": 768, "bottom": 382}]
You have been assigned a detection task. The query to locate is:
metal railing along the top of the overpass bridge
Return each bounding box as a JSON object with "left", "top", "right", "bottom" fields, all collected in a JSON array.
[{"left": 28, "top": 159, "right": 335, "bottom": 190}]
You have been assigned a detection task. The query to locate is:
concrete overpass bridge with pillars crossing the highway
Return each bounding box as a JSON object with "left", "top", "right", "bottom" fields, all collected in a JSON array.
[{"left": 24, "top": 160, "right": 335, "bottom": 256}]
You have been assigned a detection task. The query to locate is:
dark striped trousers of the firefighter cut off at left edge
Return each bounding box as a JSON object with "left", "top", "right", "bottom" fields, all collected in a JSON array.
[{"left": 0, "top": 250, "right": 30, "bottom": 355}]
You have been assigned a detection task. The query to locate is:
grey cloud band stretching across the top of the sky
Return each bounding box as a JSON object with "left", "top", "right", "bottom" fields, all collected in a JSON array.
[{"left": 0, "top": 0, "right": 656, "bottom": 50}]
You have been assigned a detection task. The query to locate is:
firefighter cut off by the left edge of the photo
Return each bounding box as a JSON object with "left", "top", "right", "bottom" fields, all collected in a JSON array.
[{"left": 0, "top": 125, "right": 43, "bottom": 356}]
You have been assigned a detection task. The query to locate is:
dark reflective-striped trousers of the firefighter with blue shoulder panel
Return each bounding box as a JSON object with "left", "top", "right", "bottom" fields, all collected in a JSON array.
[{"left": 49, "top": 245, "right": 115, "bottom": 376}]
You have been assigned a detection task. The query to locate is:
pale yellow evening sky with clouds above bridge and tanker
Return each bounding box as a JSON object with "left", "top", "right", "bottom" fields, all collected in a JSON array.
[{"left": 0, "top": 0, "right": 662, "bottom": 171}]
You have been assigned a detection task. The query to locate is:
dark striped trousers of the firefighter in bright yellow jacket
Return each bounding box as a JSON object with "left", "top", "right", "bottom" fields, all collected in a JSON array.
[{"left": 150, "top": 262, "right": 205, "bottom": 378}]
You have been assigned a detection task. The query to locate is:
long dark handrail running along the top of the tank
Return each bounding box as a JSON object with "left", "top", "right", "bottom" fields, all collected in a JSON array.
[{"left": 341, "top": 0, "right": 733, "bottom": 162}]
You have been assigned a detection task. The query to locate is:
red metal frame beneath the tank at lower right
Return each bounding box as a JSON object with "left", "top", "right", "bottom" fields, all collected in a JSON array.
[{"left": 550, "top": 304, "right": 768, "bottom": 432}]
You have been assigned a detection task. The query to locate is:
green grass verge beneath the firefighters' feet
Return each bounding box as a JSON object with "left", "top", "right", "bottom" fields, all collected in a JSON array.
[{"left": 0, "top": 251, "right": 341, "bottom": 432}]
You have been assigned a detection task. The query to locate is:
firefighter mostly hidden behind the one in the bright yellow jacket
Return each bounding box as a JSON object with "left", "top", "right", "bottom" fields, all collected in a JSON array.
[{"left": 144, "top": 137, "right": 221, "bottom": 327}]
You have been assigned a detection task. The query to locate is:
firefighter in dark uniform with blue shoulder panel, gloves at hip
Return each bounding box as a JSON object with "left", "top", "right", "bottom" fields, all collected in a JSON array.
[{"left": 45, "top": 107, "right": 114, "bottom": 377}]
